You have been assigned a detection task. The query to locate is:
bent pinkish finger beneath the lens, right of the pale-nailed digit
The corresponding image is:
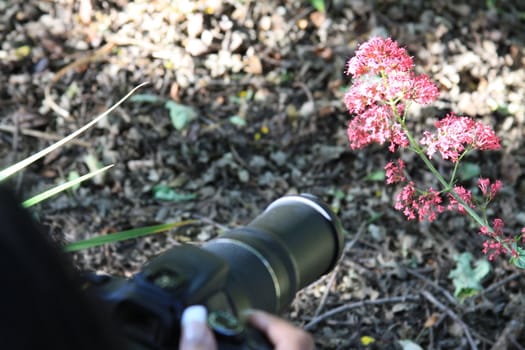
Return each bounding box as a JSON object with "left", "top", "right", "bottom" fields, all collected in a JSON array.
[{"left": 247, "top": 311, "right": 314, "bottom": 350}]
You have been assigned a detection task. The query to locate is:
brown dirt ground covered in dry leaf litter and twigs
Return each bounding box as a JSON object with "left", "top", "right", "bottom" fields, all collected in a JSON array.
[{"left": 0, "top": 0, "right": 525, "bottom": 349}]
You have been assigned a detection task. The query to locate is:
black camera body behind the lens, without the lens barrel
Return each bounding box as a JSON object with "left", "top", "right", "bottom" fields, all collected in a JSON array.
[{"left": 88, "top": 245, "right": 272, "bottom": 350}]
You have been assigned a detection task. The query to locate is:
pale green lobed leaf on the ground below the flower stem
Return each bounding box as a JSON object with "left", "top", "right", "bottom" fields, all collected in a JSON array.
[{"left": 448, "top": 252, "right": 490, "bottom": 301}]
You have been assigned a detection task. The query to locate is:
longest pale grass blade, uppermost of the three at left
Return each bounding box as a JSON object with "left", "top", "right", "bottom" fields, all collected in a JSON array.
[{"left": 0, "top": 83, "right": 148, "bottom": 182}]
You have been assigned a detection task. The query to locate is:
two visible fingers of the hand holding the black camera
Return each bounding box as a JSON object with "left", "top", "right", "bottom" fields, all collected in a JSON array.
[{"left": 179, "top": 305, "right": 315, "bottom": 350}]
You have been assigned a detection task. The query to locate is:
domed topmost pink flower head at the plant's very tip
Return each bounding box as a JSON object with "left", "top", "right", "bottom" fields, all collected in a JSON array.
[{"left": 346, "top": 37, "right": 414, "bottom": 78}]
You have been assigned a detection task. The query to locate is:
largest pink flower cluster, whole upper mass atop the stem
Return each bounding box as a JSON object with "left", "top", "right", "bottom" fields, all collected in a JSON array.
[{"left": 344, "top": 37, "right": 439, "bottom": 152}]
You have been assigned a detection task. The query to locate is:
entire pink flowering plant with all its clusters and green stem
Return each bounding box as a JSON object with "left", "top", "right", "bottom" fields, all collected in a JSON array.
[{"left": 344, "top": 37, "right": 525, "bottom": 266}]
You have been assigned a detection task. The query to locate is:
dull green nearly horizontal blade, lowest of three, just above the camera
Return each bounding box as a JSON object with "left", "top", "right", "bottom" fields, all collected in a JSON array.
[{"left": 64, "top": 220, "right": 198, "bottom": 252}]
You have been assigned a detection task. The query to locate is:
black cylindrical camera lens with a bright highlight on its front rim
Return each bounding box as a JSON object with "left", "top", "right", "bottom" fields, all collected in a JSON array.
[{"left": 203, "top": 194, "right": 343, "bottom": 313}]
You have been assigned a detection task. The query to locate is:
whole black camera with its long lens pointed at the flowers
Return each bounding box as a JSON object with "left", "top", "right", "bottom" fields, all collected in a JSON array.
[{"left": 87, "top": 194, "right": 343, "bottom": 350}]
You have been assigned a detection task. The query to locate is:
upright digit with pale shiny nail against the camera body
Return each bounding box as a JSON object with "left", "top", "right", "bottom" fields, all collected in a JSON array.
[{"left": 179, "top": 305, "right": 217, "bottom": 350}]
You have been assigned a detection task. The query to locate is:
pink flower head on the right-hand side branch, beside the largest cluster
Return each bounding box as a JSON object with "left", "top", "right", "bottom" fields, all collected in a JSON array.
[{"left": 419, "top": 113, "right": 500, "bottom": 163}]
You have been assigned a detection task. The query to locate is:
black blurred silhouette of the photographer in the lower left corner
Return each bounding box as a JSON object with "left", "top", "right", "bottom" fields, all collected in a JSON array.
[{"left": 0, "top": 186, "right": 124, "bottom": 350}]
